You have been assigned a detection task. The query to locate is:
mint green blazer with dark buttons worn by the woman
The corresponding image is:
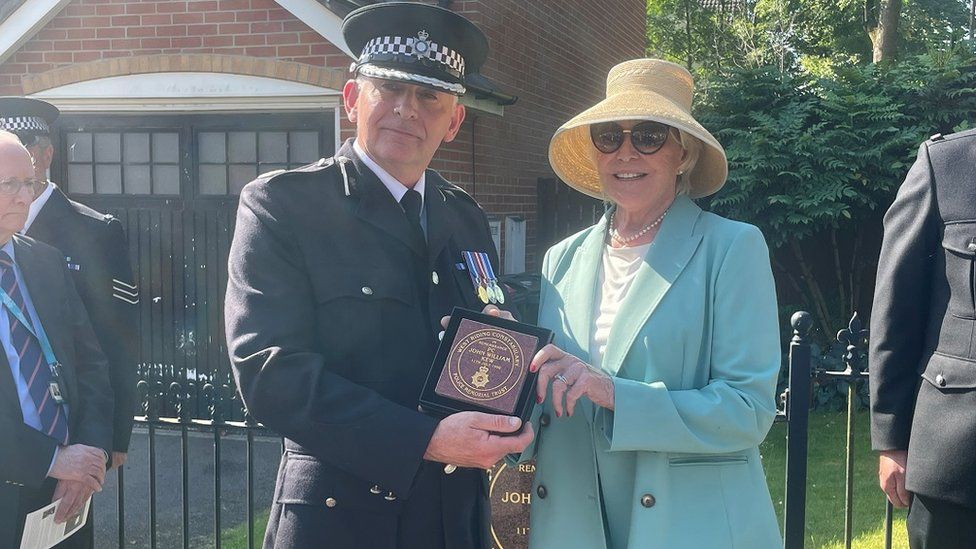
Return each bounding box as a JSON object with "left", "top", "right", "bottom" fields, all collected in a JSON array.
[{"left": 521, "top": 197, "right": 782, "bottom": 549}]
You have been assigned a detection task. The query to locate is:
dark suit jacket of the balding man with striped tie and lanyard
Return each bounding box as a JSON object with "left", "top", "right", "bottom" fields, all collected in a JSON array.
[{"left": 0, "top": 235, "right": 112, "bottom": 547}]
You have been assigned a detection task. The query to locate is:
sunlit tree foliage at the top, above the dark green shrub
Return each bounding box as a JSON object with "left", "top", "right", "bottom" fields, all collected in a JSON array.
[{"left": 647, "top": 0, "right": 969, "bottom": 75}]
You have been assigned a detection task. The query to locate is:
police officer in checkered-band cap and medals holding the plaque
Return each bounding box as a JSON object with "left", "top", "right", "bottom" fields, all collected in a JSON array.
[{"left": 225, "top": 2, "right": 532, "bottom": 549}]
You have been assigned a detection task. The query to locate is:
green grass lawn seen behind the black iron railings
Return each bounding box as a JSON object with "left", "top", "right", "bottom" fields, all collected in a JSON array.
[{"left": 221, "top": 411, "right": 908, "bottom": 549}]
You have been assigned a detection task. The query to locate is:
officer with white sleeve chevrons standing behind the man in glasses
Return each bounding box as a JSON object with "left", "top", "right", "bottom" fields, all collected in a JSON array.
[{"left": 0, "top": 97, "right": 141, "bottom": 547}]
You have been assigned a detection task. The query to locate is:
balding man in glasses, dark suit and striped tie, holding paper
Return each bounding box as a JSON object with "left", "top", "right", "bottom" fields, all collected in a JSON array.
[{"left": 0, "top": 131, "right": 112, "bottom": 547}]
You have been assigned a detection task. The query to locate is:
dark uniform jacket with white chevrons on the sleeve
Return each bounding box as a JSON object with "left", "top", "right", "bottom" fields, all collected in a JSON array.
[{"left": 27, "top": 187, "right": 140, "bottom": 452}]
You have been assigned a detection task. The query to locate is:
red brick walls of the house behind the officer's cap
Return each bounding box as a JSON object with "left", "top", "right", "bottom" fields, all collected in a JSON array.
[{"left": 0, "top": 0, "right": 645, "bottom": 270}]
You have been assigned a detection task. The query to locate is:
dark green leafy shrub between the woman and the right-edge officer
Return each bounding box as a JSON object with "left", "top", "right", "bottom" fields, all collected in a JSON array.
[{"left": 696, "top": 52, "right": 976, "bottom": 341}]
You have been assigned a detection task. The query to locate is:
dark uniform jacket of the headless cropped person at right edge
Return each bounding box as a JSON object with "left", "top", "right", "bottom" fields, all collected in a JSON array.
[{"left": 870, "top": 131, "right": 976, "bottom": 508}]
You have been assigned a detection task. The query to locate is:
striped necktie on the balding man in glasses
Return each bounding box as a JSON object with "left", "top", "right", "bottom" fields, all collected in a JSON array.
[{"left": 0, "top": 250, "right": 68, "bottom": 444}]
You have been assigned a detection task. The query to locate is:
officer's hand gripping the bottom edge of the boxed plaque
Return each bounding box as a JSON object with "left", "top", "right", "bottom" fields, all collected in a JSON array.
[{"left": 424, "top": 412, "right": 535, "bottom": 469}]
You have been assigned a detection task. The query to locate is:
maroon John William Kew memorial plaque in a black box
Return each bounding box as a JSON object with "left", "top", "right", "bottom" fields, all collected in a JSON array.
[{"left": 420, "top": 307, "right": 552, "bottom": 422}]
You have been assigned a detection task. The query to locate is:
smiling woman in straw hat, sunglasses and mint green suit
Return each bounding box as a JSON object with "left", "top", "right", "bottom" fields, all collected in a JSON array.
[{"left": 521, "top": 59, "right": 782, "bottom": 549}]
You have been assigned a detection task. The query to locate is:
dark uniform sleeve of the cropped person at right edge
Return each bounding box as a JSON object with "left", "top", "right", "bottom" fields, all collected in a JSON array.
[{"left": 869, "top": 144, "right": 940, "bottom": 450}]
